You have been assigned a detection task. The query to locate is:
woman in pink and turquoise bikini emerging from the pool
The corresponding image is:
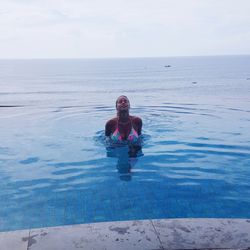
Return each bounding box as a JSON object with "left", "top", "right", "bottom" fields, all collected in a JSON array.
[{"left": 105, "top": 95, "right": 142, "bottom": 144}]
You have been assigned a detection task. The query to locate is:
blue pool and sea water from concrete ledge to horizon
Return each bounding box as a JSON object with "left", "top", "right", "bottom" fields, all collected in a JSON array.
[{"left": 0, "top": 56, "right": 250, "bottom": 231}]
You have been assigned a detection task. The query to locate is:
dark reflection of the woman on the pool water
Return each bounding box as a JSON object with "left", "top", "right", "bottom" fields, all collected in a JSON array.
[{"left": 106, "top": 145, "right": 143, "bottom": 181}]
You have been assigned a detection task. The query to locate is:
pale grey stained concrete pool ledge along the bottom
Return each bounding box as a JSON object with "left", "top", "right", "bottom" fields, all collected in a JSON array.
[{"left": 0, "top": 219, "right": 250, "bottom": 250}]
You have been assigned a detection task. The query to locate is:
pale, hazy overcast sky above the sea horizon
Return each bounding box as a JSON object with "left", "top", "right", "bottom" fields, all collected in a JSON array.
[{"left": 0, "top": 0, "right": 250, "bottom": 59}]
